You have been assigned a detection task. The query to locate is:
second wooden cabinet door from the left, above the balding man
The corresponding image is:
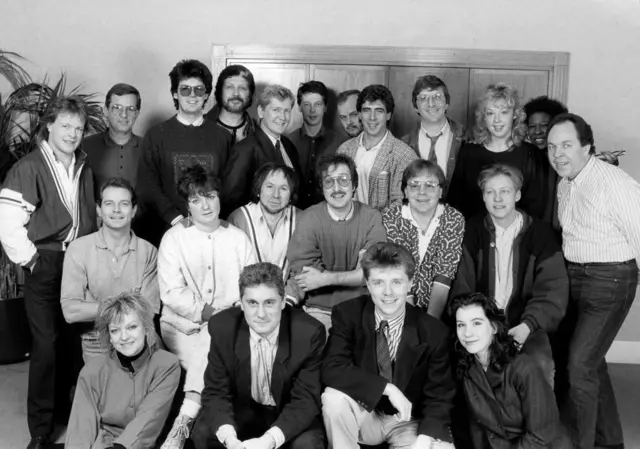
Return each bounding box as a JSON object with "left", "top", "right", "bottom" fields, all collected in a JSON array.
[{"left": 309, "top": 64, "right": 389, "bottom": 132}]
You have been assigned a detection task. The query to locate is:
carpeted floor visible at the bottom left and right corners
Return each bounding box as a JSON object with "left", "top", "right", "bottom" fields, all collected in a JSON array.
[{"left": 0, "top": 362, "right": 640, "bottom": 449}]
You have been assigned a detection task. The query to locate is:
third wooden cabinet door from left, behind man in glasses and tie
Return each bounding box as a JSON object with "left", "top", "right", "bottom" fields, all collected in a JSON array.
[{"left": 389, "top": 67, "right": 469, "bottom": 138}]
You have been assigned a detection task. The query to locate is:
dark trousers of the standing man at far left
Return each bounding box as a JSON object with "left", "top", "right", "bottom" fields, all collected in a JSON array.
[{"left": 24, "top": 250, "right": 78, "bottom": 437}]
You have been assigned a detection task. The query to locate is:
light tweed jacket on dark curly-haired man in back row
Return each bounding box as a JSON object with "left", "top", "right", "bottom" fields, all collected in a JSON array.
[{"left": 337, "top": 131, "right": 419, "bottom": 212}]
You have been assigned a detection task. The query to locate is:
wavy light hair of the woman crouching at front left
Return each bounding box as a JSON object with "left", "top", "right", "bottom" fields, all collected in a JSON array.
[{"left": 95, "top": 292, "right": 156, "bottom": 349}]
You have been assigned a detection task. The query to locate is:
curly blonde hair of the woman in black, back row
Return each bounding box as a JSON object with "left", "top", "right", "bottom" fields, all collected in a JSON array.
[{"left": 473, "top": 83, "right": 527, "bottom": 146}]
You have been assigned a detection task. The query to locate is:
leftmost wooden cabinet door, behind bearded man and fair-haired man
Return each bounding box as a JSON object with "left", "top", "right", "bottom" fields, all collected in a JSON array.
[{"left": 227, "top": 59, "right": 308, "bottom": 134}]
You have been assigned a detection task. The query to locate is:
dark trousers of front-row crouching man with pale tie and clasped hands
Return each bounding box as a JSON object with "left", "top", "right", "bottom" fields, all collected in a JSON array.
[{"left": 191, "top": 401, "right": 326, "bottom": 449}]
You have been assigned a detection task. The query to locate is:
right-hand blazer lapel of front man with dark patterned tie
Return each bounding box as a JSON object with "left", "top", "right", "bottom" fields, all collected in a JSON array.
[{"left": 393, "top": 304, "right": 427, "bottom": 391}]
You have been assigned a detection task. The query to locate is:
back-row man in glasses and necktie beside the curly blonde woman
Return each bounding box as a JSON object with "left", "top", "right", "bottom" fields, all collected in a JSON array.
[{"left": 402, "top": 75, "right": 465, "bottom": 188}]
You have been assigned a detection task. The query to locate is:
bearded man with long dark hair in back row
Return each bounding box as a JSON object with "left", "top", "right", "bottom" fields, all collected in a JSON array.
[{"left": 207, "top": 65, "right": 256, "bottom": 146}]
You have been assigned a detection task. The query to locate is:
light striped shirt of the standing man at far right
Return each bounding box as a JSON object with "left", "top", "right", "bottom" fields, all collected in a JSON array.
[{"left": 558, "top": 157, "right": 640, "bottom": 263}]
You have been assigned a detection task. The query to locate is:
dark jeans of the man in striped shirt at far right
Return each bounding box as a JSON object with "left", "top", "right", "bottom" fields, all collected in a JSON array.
[{"left": 567, "top": 261, "right": 638, "bottom": 449}]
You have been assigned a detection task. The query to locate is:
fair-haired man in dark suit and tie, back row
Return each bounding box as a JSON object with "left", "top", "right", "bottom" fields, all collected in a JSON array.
[{"left": 221, "top": 84, "right": 305, "bottom": 217}]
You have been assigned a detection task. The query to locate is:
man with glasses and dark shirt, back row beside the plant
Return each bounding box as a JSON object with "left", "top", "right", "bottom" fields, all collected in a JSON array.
[{"left": 82, "top": 83, "right": 142, "bottom": 192}]
